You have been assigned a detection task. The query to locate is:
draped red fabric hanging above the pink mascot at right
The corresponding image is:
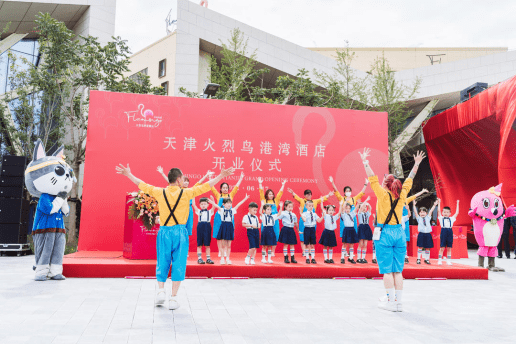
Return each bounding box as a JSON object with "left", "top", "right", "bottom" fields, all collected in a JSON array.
[{"left": 423, "top": 77, "right": 516, "bottom": 226}]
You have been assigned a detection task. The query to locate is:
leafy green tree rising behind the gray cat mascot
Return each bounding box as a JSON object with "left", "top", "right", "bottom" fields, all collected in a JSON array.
[{"left": 0, "top": 13, "right": 164, "bottom": 243}]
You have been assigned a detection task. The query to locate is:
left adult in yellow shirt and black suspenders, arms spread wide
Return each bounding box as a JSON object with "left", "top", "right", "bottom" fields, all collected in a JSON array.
[{"left": 116, "top": 164, "right": 235, "bottom": 309}]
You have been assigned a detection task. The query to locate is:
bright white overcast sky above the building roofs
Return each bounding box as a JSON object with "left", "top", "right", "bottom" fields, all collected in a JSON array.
[{"left": 115, "top": 0, "right": 516, "bottom": 53}]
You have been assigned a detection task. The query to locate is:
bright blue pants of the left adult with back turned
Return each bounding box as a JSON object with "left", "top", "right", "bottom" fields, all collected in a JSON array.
[{"left": 156, "top": 225, "right": 189, "bottom": 282}]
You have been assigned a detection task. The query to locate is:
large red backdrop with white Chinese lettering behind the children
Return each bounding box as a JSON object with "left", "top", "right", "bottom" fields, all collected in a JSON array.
[{"left": 79, "top": 91, "right": 388, "bottom": 252}]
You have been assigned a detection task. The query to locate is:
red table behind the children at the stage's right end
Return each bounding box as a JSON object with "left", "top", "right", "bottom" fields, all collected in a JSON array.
[{"left": 408, "top": 226, "right": 468, "bottom": 259}]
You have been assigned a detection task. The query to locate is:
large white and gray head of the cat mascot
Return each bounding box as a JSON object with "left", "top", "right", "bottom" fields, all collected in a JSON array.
[{"left": 25, "top": 139, "right": 77, "bottom": 197}]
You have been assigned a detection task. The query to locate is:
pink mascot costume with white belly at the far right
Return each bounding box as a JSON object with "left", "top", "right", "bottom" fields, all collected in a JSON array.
[{"left": 468, "top": 184, "right": 516, "bottom": 271}]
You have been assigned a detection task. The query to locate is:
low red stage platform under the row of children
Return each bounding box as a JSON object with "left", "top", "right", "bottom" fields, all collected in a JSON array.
[{"left": 63, "top": 251, "right": 488, "bottom": 280}]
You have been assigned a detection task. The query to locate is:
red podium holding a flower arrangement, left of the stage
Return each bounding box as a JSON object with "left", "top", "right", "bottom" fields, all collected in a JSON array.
[{"left": 124, "top": 195, "right": 159, "bottom": 259}]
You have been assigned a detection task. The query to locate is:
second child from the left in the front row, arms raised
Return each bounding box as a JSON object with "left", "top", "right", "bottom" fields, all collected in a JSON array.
[{"left": 210, "top": 195, "right": 249, "bottom": 265}]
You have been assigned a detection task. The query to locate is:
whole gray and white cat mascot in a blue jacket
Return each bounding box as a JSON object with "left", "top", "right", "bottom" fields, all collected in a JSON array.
[{"left": 25, "top": 139, "right": 77, "bottom": 281}]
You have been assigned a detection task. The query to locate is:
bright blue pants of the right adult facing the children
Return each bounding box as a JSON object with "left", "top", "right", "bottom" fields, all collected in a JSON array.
[{"left": 374, "top": 224, "right": 407, "bottom": 274}]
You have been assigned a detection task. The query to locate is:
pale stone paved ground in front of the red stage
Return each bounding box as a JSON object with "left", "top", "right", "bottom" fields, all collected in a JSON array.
[{"left": 0, "top": 251, "right": 516, "bottom": 344}]
